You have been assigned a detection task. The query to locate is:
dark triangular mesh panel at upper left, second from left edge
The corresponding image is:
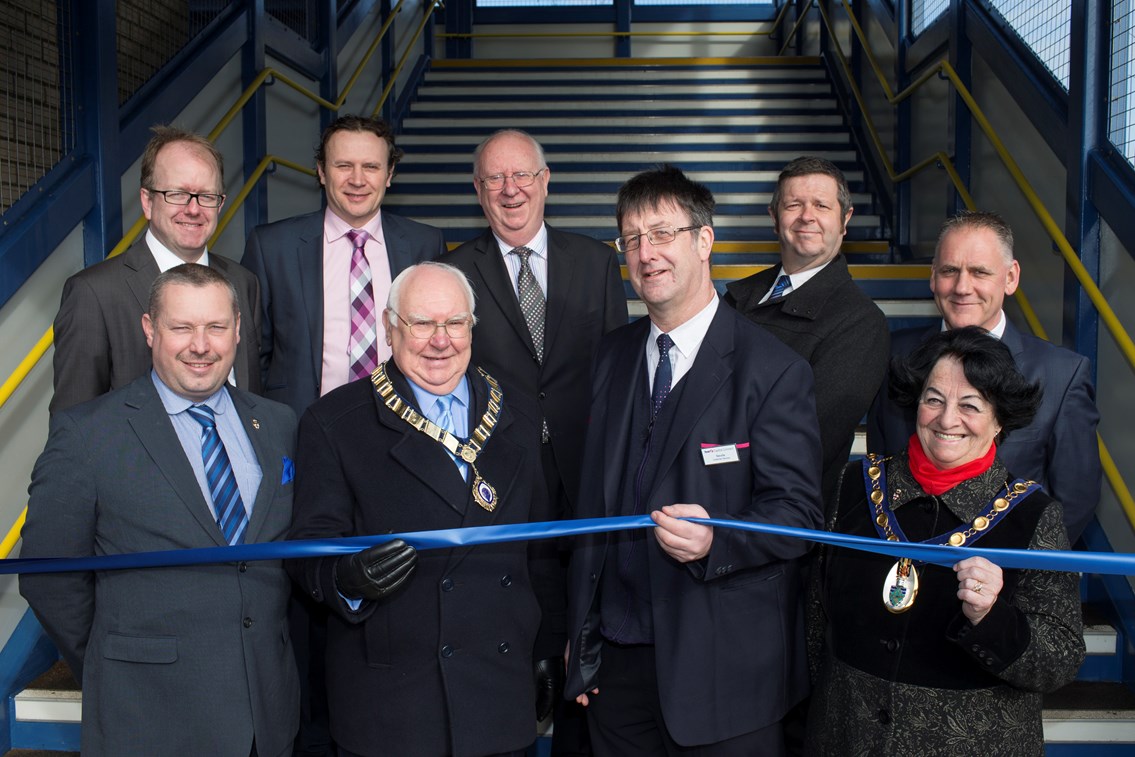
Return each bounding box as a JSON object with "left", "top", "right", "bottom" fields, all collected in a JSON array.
[{"left": 116, "top": 0, "right": 229, "bottom": 104}]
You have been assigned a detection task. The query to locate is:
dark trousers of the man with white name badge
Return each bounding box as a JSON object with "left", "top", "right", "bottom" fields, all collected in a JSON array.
[{"left": 587, "top": 642, "right": 784, "bottom": 757}]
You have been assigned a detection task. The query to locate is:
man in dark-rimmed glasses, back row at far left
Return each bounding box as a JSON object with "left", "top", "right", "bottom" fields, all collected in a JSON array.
[{"left": 50, "top": 126, "right": 260, "bottom": 413}]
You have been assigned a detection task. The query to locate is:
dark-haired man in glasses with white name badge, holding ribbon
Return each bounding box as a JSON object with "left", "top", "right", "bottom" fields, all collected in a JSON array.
[{"left": 565, "top": 166, "right": 822, "bottom": 757}]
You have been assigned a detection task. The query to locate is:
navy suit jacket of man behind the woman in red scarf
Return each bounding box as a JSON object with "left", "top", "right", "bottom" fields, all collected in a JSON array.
[{"left": 867, "top": 322, "right": 1103, "bottom": 544}]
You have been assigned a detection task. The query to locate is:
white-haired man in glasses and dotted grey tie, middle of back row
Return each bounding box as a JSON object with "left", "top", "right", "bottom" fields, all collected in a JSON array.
[{"left": 445, "top": 129, "right": 627, "bottom": 757}]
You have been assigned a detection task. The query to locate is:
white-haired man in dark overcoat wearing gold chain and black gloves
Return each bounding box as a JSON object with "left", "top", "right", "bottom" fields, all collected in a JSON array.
[{"left": 287, "top": 262, "right": 564, "bottom": 757}]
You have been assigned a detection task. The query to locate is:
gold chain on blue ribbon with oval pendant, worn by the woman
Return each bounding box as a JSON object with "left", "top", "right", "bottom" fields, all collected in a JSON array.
[{"left": 863, "top": 454, "right": 1040, "bottom": 614}]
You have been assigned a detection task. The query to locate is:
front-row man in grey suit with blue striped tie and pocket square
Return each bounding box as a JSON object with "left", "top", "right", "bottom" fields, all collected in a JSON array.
[{"left": 19, "top": 266, "right": 299, "bottom": 757}]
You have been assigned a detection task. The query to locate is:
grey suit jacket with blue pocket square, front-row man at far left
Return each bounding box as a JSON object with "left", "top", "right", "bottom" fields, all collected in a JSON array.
[{"left": 19, "top": 373, "right": 300, "bottom": 757}]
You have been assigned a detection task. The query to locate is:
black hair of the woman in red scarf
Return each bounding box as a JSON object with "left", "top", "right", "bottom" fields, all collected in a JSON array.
[{"left": 889, "top": 326, "right": 1043, "bottom": 441}]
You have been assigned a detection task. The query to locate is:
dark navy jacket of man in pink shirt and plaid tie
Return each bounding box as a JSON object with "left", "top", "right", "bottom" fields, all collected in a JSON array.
[{"left": 241, "top": 210, "right": 445, "bottom": 415}]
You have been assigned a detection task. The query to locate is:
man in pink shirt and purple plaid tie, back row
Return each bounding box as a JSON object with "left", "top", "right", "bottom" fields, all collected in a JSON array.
[{"left": 241, "top": 116, "right": 445, "bottom": 415}]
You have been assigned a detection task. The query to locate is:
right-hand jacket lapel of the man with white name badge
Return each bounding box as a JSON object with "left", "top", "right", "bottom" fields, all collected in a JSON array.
[{"left": 650, "top": 303, "right": 735, "bottom": 503}]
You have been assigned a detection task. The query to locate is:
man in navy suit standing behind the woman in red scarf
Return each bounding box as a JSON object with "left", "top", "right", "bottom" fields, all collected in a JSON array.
[{"left": 867, "top": 212, "right": 1102, "bottom": 542}]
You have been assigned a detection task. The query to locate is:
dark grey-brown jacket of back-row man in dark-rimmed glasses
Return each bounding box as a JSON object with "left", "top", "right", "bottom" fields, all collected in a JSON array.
[{"left": 51, "top": 237, "right": 260, "bottom": 413}]
